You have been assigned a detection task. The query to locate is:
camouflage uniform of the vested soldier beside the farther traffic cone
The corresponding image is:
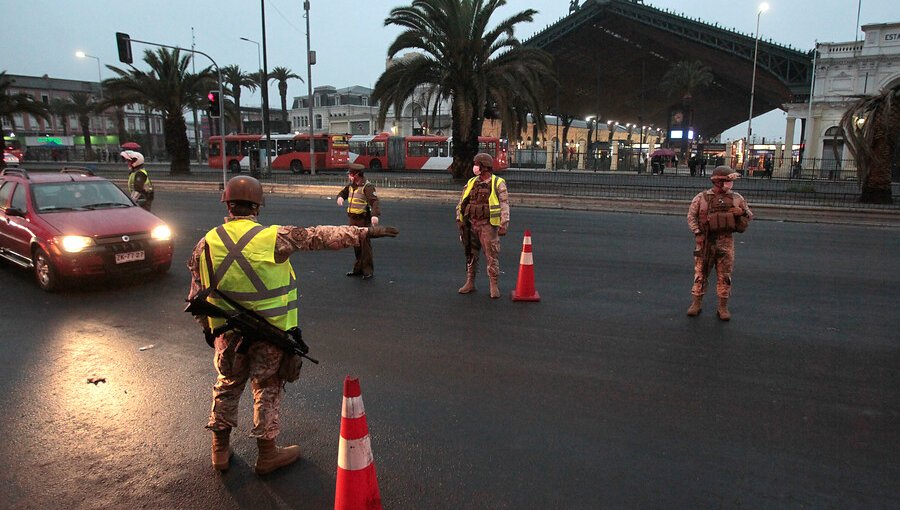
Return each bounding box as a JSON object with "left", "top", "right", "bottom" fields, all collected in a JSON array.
[{"left": 456, "top": 174, "right": 509, "bottom": 279}]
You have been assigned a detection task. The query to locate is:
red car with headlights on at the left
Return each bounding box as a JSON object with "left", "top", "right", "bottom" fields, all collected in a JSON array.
[{"left": 0, "top": 168, "right": 172, "bottom": 292}]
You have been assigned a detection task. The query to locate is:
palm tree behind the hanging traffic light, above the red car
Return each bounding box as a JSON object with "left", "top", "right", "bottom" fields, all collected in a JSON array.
[{"left": 104, "top": 48, "right": 216, "bottom": 174}]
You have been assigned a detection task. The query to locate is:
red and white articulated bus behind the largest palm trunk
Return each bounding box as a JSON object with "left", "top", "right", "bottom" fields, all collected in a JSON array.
[{"left": 349, "top": 133, "right": 509, "bottom": 171}]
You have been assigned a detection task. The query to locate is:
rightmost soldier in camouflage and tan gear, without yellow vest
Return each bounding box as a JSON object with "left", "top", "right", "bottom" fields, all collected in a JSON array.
[{"left": 687, "top": 166, "right": 753, "bottom": 321}]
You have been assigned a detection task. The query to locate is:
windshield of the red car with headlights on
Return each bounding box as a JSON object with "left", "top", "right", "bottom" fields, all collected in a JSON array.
[{"left": 32, "top": 181, "right": 134, "bottom": 212}]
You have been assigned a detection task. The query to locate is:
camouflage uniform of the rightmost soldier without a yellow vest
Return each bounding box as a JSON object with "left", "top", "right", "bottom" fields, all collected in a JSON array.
[{"left": 687, "top": 188, "right": 753, "bottom": 299}]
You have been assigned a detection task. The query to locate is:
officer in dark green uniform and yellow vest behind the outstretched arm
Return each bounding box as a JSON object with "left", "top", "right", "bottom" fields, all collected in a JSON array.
[{"left": 337, "top": 163, "right": 381, "bottom": 280}]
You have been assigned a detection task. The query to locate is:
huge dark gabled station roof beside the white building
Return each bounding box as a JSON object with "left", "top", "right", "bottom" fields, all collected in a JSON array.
[{"left": 523, "top": 0, "right": 812, "bottom": 137}]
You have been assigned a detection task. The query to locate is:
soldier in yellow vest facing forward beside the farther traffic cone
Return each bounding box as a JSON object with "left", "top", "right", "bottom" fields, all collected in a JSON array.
[{"left": 456, "top": 152, "right": 509, "bottom": 299}]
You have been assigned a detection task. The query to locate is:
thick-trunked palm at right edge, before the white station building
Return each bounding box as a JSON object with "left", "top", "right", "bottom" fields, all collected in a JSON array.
[{"left": 841, "top": 84, "right": 900, "bottom": 204}]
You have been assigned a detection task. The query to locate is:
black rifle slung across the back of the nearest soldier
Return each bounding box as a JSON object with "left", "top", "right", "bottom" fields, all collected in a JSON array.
[{"left": 184, "top": 287, "right": 319, "bottom": 364}]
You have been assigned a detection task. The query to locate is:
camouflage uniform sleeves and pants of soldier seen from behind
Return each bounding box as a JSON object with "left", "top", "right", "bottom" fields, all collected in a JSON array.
[{"left": 188, "top": 216, "right": 368, "bottom": 440}]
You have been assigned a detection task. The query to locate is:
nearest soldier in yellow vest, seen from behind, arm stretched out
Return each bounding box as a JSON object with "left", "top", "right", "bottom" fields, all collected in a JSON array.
[{"left": 188, "top": 175, "right": 398, "bottom": 475}]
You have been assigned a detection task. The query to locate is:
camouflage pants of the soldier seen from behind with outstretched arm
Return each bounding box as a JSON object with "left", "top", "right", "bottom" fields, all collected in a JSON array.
[{"left": 206, "top": 331, "right": 284, "bottom": 439}]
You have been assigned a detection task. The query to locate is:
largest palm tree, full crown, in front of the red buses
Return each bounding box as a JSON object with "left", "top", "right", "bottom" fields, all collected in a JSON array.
[{"left": 372, "top": 0, "right": 556, "bottom": 179}]
